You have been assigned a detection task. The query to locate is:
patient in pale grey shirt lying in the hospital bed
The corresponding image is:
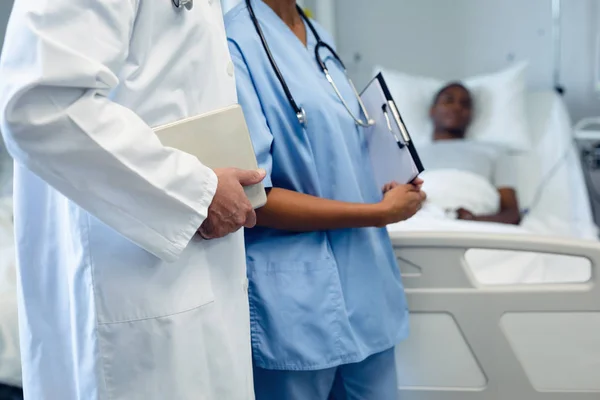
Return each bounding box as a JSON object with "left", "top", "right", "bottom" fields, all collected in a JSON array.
[{"left": 419, "top": 83, "right": 520, "bottom": 224}]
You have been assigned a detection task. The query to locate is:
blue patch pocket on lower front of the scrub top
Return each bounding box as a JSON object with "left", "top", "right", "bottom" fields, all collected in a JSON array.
[{"left": 248, "top": 259, "right": 347, "bottom": 369}]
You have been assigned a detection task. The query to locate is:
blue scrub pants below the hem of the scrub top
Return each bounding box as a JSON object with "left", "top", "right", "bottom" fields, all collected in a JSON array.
[{"left": 254, "top": 348, "right": 398, "bottom": 400}]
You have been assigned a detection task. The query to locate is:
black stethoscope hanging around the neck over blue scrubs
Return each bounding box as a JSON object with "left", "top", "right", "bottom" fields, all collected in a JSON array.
[{"left": 246, "top": 0, "right": 375, "bottom": 127}]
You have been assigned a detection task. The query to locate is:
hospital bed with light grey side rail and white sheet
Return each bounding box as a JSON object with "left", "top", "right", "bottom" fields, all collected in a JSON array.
[{"left": 389, "top": 91, "right": 600, "bottom": 400}]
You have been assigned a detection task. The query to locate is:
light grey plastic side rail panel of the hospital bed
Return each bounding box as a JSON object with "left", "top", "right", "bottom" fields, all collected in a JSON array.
[{"left": 391, "top": 232, "right": 600, "bottom": 400}]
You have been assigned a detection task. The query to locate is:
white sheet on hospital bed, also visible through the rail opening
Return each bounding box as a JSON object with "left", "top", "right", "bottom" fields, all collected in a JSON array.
[{"left": 388, "top": 91, "right": 598, "bottom": 285}]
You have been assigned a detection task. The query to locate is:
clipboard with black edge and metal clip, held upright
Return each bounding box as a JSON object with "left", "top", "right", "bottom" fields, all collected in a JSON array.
[{"left": 360, "top": 72, "right": 424, "bottom": 188}]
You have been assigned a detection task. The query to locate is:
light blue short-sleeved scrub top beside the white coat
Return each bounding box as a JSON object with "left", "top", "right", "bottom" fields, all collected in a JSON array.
[{"left": 225, "top": 0, "right": 408, "bottom": 370}]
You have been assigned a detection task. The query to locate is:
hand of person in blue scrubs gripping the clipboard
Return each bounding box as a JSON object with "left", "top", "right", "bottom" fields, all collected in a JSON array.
[{"left": 380, "top": 183, "right": 427, "bottom": 226}]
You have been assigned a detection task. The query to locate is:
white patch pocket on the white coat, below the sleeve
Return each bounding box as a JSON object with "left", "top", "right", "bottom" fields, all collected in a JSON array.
[{"left": 89, "top": 218, "right": 214, "bottom": 324}]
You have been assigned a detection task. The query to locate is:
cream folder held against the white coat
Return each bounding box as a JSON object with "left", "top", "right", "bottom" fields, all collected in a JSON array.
[{"left": 154, "top": 104, "right": 267, "bottom": 209}]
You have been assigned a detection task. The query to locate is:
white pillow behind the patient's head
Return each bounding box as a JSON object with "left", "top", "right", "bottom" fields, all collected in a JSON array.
[{"left": 376, "top": 62, "right": 531, "bottom": 151}]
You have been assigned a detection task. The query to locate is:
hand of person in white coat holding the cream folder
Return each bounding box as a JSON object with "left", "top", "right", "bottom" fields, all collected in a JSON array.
[{"left": 198, "top": 168, "right": 266, "bottom": 239}]
